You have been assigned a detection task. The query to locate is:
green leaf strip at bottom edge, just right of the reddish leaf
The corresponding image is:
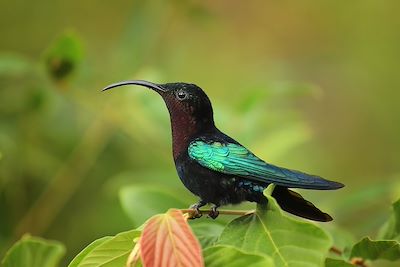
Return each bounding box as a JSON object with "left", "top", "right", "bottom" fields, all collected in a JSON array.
[{"left": 203, "top": 245, "right": 275, "bottom": 267}]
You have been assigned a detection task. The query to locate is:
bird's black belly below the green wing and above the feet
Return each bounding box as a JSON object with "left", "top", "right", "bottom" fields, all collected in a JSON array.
[{"left": 176, "top": 159, "right": 265, "bottom": 205}]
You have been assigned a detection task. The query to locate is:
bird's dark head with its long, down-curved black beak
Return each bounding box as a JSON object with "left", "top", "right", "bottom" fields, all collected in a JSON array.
[{"left": 103, "top": 80, "right": 214, "bottom": 130}]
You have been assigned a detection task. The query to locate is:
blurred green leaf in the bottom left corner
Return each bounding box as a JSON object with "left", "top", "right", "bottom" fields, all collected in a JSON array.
[{"left": 1, "top": 235, "right": 65, "bottom": 267}]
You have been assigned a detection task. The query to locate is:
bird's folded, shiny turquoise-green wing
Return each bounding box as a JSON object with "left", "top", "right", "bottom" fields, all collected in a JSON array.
[{"left": 188, "top": 140, "right": 343, "bottom": 189}]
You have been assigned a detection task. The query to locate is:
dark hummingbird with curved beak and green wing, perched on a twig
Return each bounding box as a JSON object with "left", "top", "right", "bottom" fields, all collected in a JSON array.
[{"left": 103, "top": 80, "right": 344, "bottom": 222}]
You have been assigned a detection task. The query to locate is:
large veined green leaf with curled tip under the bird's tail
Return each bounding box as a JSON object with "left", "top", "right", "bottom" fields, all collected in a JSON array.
[{"left": 219, "top": 187, "right": 332, "bottom": 267}]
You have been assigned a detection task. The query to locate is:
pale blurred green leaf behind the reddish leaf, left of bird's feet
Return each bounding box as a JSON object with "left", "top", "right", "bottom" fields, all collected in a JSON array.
[{"left": 119, "top": 185, "right": 188, "bottom": 226}]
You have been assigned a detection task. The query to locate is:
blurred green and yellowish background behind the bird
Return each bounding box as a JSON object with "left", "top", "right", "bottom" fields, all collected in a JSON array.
[{"left": 0, "top": 0, "right": 400, "bottom": 261}]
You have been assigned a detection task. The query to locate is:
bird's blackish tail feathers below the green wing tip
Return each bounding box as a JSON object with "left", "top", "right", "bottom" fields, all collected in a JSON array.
[{"left": 272, "top": 186, "right": 332, "bottom": 222}]
